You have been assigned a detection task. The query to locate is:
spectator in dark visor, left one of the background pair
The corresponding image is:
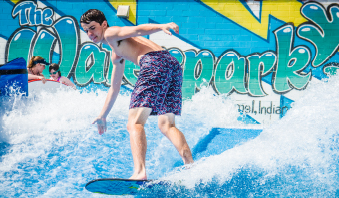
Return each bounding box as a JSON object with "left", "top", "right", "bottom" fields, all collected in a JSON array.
[{"left": 27, "top": 56, "right": 49, "bottom": 84}]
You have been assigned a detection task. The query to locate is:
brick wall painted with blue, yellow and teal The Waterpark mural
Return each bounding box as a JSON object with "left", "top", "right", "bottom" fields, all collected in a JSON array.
[{"left": 0, "top": 0, "right": 339, "bottom": 123}]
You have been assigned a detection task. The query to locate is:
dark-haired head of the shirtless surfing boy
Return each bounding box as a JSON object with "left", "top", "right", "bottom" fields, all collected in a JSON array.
[{"left": 80, "top": 9, "right": 108, "bottom": 43}]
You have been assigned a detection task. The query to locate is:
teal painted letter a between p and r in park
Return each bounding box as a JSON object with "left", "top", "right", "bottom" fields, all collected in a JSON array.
[{"left": 214, "top": 51, "right": 247, "bottom": 94}]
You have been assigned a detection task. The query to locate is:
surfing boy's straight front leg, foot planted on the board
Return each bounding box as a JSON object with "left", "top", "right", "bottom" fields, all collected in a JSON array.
[{"left": 127, "top": 107, "right": 152, "bottom": 180}]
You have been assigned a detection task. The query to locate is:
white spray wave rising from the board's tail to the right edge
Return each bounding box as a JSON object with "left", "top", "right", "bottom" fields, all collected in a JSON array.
[{"left": 164, "top": 76, "right": 339, "bottom": 197}]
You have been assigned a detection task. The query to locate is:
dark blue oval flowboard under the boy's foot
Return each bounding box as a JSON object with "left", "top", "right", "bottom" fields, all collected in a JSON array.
[{"left": 85, "top": 178, "right": 164, "bottom": 195}]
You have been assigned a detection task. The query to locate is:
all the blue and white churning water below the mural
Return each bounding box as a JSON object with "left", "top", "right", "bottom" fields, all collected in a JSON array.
[{"left": 0, "top": 76, "right": 339, "bottom": 197}]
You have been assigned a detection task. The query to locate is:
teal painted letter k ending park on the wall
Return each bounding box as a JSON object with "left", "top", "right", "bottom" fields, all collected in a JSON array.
[{"left": 273, "top": 24, "right": 311, "bottom": 93}]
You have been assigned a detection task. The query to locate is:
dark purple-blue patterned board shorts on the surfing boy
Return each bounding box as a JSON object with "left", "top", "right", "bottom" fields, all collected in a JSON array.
[{"left": 129, "top": 50, "right": 182, "bottom": 115}]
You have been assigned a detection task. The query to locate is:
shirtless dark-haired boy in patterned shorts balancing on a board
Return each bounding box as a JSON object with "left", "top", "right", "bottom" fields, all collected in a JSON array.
[{"left": 80, "top": 9, "right": 193, "bottom": 180}]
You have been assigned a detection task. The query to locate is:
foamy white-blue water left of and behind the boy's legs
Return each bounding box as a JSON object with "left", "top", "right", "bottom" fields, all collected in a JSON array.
[{"left": 0, "top": 84, "right": 242, "bottom": 197}]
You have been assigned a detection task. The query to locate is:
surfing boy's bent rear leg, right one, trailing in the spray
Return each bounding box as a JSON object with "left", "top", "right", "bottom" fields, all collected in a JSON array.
[{"left": 158, "top": 113, "right": 194, "bottom": 164}]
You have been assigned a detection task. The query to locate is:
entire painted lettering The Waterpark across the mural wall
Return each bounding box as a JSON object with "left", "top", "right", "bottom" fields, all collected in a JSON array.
[{"left": 5, "top": 0, "right": 339, "bottom": 109}]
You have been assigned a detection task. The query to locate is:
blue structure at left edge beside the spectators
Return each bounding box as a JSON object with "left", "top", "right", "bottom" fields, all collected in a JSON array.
[{"left": 0, "top": 58, "right": 28, "bottom": 96}]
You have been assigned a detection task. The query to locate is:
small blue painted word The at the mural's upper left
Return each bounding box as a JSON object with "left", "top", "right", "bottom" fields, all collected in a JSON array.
[{"left": 12, "top": 1, "right": 53, "bottom": 26}]
